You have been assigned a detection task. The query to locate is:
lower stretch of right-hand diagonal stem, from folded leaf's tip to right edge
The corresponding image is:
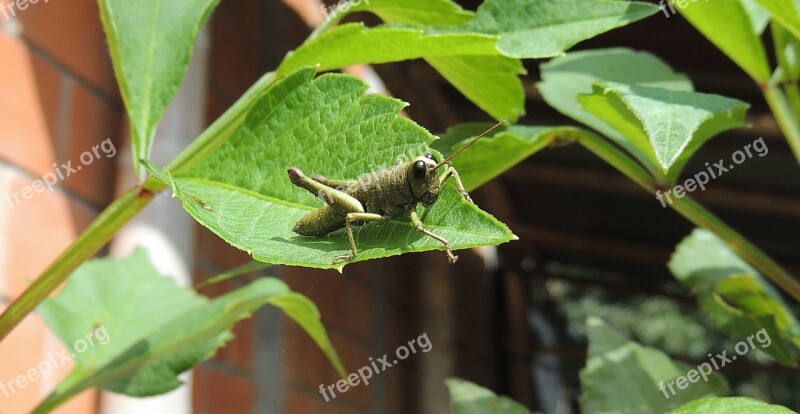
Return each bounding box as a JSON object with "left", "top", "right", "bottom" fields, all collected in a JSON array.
[{"left": 671, "top": 197, "right": 800, "bottom": 301}]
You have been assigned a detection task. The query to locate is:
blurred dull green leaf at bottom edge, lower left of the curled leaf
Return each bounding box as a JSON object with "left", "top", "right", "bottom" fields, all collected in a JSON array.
[{"left": 580, "top": 317, "right": 728, "bottom": 414}]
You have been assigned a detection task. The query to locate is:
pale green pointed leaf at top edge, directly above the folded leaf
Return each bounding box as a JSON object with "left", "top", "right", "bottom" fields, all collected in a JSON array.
[{"left": 461, "top": 0, "right": 659, "bottom": 58}]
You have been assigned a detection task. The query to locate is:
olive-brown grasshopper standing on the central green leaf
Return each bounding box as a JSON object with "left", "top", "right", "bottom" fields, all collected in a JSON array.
[{"left": 287, "top": 121, "right": 505, "bottom": 264}]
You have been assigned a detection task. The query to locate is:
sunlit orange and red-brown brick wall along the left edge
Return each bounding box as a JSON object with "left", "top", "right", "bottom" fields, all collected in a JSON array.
[{"left": 0, "top": 1, "right": 123, "bottom": 413}]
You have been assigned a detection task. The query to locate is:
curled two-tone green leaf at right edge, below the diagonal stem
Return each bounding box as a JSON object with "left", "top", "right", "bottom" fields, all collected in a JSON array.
[{"left": 669, "top": 229, "right": 800, "bottom": 366}]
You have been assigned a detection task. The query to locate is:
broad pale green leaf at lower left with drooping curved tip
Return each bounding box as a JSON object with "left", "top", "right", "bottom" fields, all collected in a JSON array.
[{"left": 39, "top": 250, "right": 345, "bottom": 411}]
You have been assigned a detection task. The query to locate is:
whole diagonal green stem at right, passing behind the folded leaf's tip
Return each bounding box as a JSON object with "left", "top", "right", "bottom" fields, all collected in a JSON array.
[{"left": 579, "top": 129, "right": 800, "bottom": 301}]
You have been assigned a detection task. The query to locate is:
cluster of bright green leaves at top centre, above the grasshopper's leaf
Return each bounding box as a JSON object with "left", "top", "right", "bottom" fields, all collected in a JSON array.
[{"left": 278, "top": 0, "right": 658, "bottom": 122}]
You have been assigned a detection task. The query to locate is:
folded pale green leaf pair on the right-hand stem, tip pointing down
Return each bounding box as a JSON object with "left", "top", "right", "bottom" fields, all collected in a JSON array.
[{"left": 539, "top": 49, "right": 748, "bottom": 183}]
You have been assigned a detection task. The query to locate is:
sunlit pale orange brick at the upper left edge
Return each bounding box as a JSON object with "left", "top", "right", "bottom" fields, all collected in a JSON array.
[{"left": 0, "top": 32, "right": 55, "bottom": 175}]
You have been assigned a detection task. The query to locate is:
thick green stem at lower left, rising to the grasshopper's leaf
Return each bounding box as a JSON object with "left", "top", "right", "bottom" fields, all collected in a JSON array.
[{"left": 0, "top": 186, "right": 158, "bottom": 341}]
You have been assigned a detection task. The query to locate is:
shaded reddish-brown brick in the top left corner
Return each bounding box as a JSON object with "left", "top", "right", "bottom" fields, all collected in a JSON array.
[{"left": 17, "top": 0, "right": 119, "bottom": 97}]
